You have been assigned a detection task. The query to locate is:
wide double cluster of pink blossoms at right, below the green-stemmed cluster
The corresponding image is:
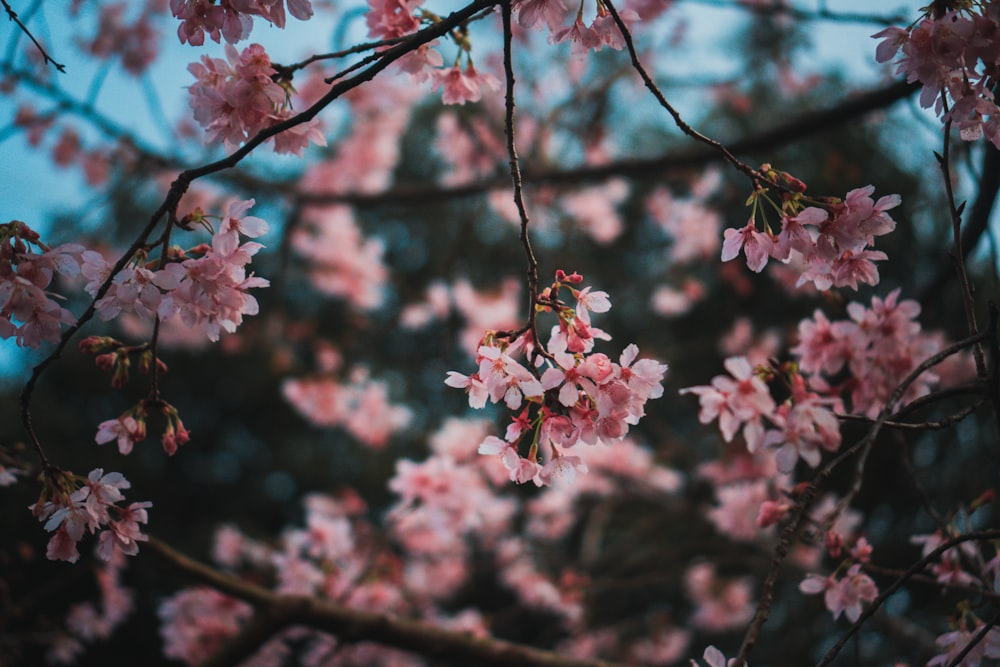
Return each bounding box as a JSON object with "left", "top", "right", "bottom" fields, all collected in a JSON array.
[{"left": 681, "top": 289, "right": 967, "bottom": 472}]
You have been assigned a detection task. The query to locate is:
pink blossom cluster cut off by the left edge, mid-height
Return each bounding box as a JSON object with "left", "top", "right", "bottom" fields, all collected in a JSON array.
[{"left": 0, "top": 220, "right": 84, "bottom": 347}]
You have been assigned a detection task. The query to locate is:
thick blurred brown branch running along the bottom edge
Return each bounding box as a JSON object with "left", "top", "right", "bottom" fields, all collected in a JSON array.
[{"left": 146, "top": 537, "right": 618, "bottom": 667}]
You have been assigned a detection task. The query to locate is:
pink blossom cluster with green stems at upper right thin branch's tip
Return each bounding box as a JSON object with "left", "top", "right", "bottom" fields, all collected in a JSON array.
[{"left": 722, "top": 180, "right": 900, "bottom": 290}]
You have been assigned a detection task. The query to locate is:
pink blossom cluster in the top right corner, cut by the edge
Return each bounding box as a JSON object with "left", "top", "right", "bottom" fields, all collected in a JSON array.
[{"left": 872, "top": 2, "right": 1000, "bottom": 147}]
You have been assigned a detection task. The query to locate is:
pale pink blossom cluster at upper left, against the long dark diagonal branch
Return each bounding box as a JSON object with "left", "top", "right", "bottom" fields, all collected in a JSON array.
[{"left": 188, "top": 44, "right": 326, "bottom": 156}]
